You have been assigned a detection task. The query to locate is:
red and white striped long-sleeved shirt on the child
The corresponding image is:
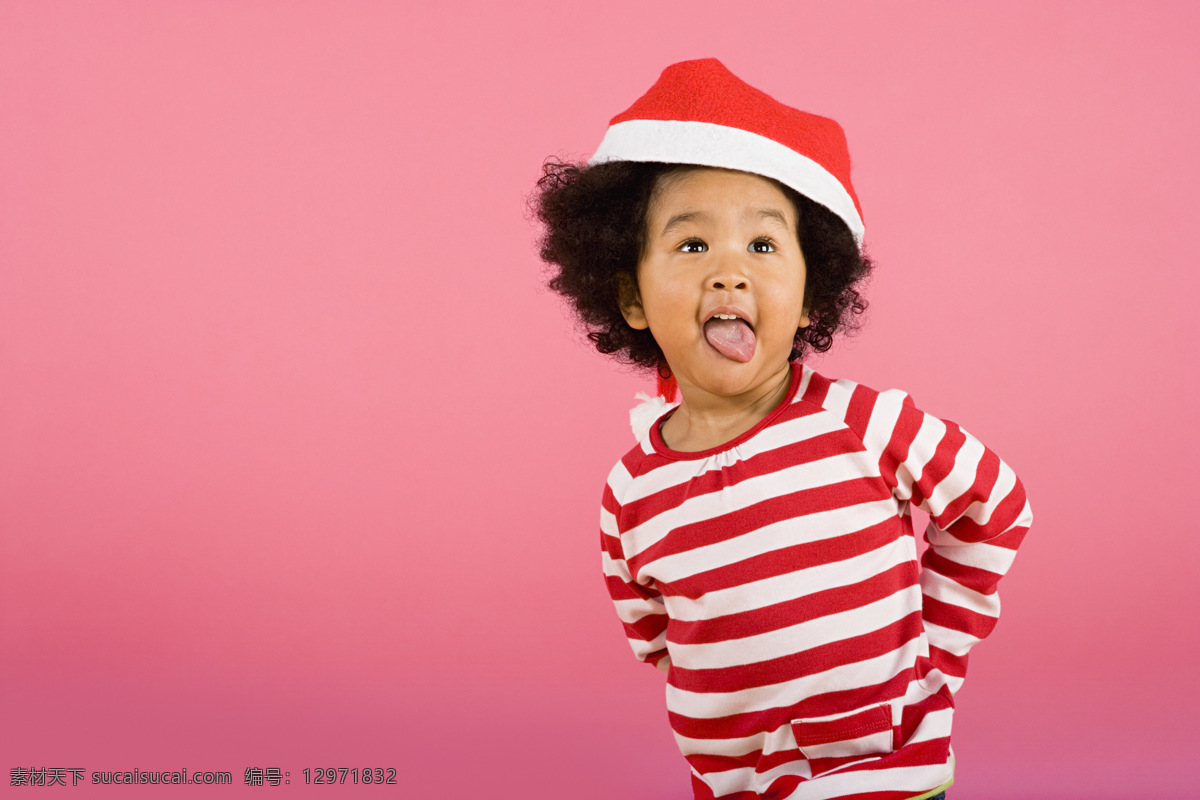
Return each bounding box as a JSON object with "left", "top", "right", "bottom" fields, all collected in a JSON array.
[{"left": 600, "top": 363, "right": 1031, "bottom": 800}]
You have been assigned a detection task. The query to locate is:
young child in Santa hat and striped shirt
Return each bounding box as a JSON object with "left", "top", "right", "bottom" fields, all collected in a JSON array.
[{"left": 539, "top": 59, "right": 1031, "bottom": 800}]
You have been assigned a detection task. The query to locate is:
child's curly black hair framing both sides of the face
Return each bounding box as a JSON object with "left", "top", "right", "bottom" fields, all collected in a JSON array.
[{"left": 530, "top": 158, "right": 872, "bottom": 377}]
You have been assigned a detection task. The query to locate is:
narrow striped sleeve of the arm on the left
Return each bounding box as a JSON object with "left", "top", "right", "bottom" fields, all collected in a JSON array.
[{"left": 600, "top": 486, "right": 670, "bottom": 666}]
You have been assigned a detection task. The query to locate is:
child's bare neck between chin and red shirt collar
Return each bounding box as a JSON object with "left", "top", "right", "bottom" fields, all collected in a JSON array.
[{"left": 661, "top": 363, "right": 792, "bottom": 452}]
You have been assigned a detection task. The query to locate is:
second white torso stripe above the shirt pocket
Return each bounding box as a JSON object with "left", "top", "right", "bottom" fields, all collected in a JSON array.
[{"left": 671, "top": 587, "right": 920, "bottom": 669}]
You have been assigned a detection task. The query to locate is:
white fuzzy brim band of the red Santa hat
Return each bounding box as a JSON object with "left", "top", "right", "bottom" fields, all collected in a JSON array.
[{"left": 588, "top": 120, "right": 864, "bottom": 245}]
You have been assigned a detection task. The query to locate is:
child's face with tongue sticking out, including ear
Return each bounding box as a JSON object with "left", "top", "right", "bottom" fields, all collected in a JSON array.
[{"left": 622, "top": 168, "right": 809, "bottom": 402}]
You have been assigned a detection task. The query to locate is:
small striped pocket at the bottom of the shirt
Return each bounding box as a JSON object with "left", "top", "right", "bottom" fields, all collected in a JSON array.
[{"left": 792, "top": 703, "right": 895, "bottom": 777}]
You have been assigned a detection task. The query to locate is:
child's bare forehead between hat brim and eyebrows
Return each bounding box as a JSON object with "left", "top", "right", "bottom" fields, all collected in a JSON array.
[{"left": 647, "top": 167, "right": 797, "bottom": 224}]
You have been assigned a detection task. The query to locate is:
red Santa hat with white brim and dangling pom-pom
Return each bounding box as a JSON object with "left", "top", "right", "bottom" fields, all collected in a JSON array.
[{"left": 588, "top": 59, "right": 864, "bottom": 438}]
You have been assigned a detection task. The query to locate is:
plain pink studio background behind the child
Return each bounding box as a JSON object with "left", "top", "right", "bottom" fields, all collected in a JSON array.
[{"left": 0, "top": 0, "right": 1200, "bottom": 800}]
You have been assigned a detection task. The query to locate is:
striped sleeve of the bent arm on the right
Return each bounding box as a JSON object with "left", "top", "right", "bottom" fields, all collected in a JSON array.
[{"left": 872, "top": 392, "right": 1032, "bottom": 692}]
